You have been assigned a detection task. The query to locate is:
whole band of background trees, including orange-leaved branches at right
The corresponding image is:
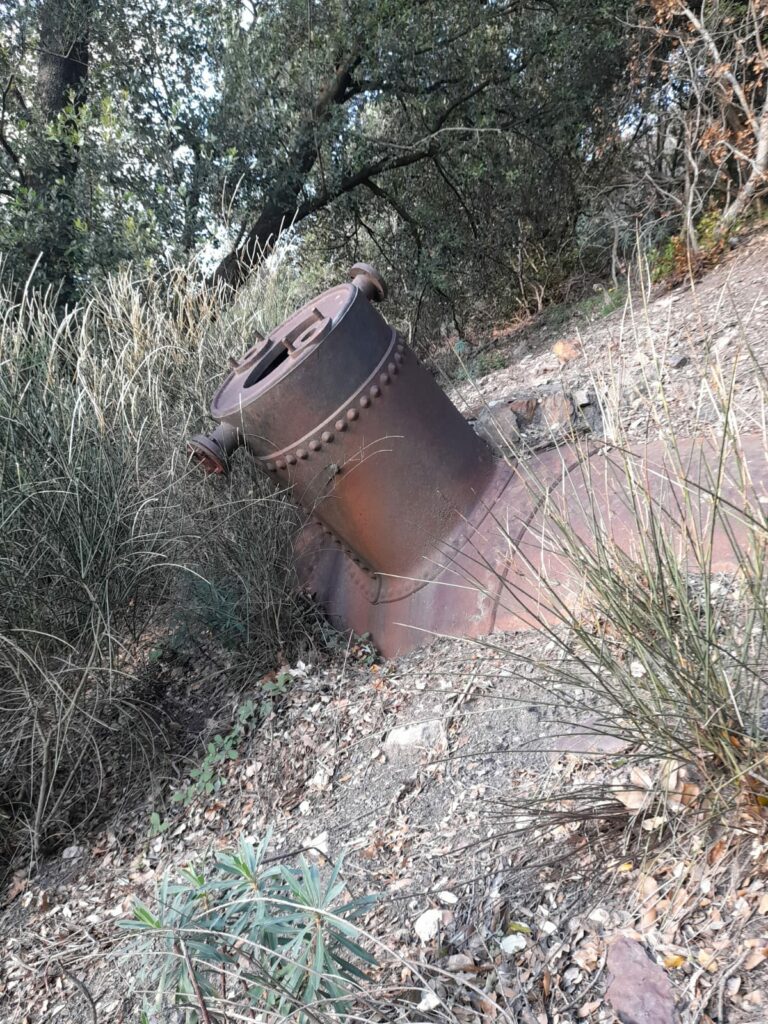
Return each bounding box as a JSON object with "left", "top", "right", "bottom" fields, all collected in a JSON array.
[{"left": 0, "top": 0, "right": 768, "bottom": 337}]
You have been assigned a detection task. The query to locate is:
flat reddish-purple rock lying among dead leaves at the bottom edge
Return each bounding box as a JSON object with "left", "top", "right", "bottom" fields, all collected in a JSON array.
[{"left": 605, "top": 936, "right": 677, "bottom": 1024}]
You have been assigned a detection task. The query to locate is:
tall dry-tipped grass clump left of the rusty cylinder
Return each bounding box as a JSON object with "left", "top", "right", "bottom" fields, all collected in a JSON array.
[{"left": 0, "top": 251, "right": 327, "bottom": 857}]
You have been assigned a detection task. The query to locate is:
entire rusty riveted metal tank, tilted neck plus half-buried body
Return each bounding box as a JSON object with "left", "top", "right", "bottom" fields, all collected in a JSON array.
[{"left": 189, "top": 263, "right": 768, "bottom": 656}]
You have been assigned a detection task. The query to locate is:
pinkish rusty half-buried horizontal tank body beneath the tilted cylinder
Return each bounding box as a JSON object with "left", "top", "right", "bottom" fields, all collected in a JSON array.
[{"left": 297, "top": 436, "right": 768, "bottom": 656}]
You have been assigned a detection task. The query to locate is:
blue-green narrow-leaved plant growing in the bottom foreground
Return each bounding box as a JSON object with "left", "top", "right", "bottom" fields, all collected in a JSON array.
[{"left": 121, "top": 834, "right": 376, "bottom": 1024}]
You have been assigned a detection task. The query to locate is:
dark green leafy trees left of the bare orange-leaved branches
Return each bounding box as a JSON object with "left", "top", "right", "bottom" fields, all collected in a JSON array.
[{"left": 0, "top": 0, "right": 626, "bottom": 325}]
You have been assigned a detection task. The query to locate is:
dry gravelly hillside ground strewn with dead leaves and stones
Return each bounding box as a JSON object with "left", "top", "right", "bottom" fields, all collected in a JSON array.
[{"left": 0, "top": 233, "right": 768, "bottom": 1024}]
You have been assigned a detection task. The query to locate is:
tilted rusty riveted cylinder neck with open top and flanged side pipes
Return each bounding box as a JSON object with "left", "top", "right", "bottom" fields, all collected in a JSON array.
[{"left": 190, "top": 265, "right": 507, "bottom": 591}]
